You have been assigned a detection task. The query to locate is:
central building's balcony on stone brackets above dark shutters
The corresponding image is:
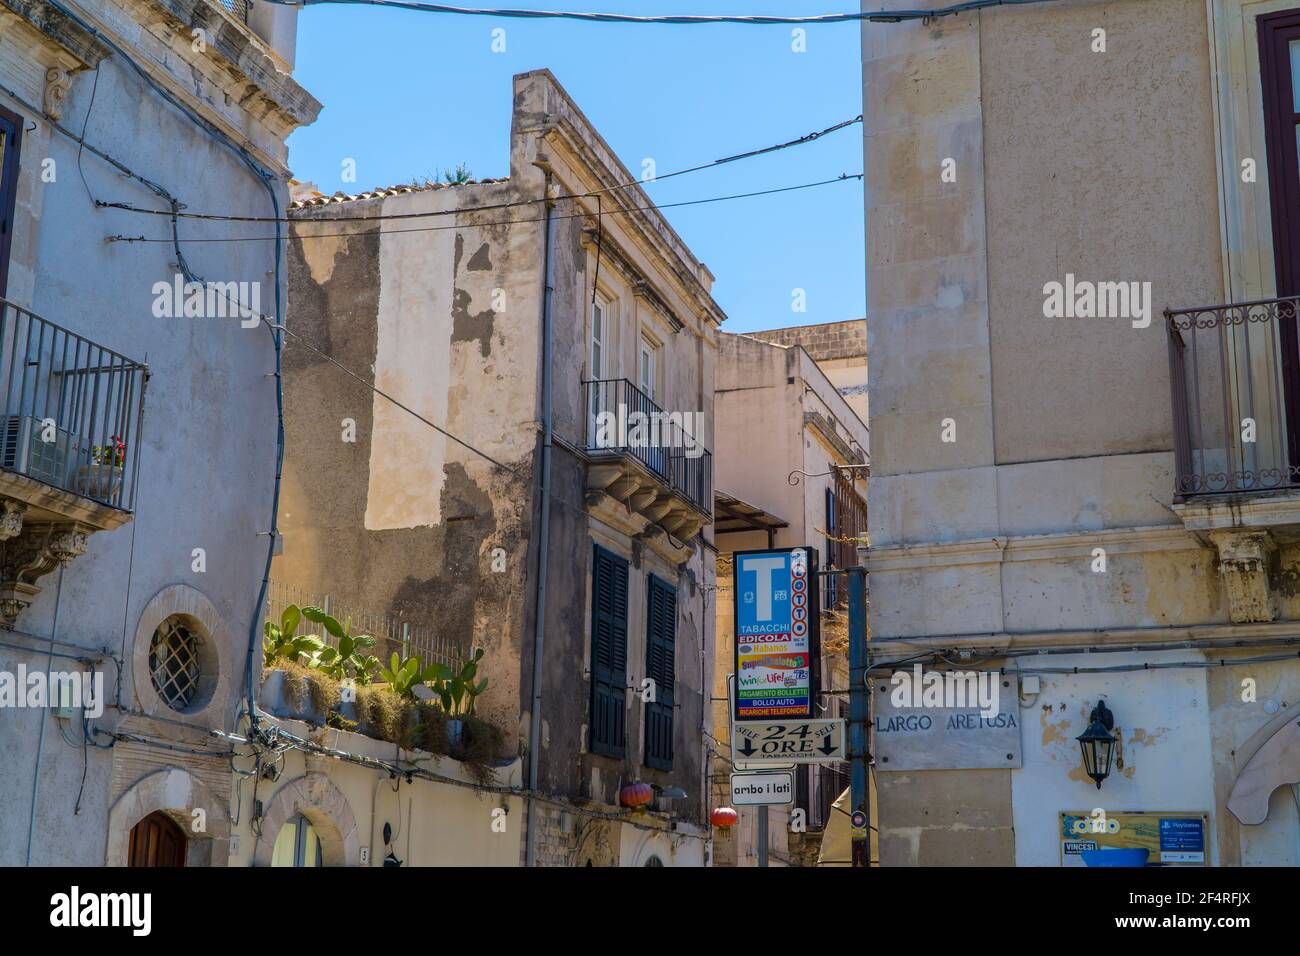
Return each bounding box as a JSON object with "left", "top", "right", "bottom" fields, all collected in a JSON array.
[{"left": 584, "top": 378, "right": 714, "bottom": 541}]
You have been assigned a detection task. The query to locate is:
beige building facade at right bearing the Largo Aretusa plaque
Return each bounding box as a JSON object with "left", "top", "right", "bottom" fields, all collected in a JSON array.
[{"left": 862, "top": 0, "right": 1300, "bottom": 866}]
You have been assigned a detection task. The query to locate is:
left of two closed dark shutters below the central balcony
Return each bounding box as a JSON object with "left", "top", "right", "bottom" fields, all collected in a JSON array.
[{"left": 589, "top": 545, "right": 628, "bottom": 757}]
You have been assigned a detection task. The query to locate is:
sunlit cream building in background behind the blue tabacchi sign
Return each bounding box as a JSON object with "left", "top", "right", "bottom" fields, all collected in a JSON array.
[{"left": 711, "top": 327, "right": 868, "bottom": 866}]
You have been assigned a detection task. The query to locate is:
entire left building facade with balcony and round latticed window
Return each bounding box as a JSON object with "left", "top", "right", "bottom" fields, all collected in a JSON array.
[{"left": 0, "top": 0, "right": 320, "bottom": 866}]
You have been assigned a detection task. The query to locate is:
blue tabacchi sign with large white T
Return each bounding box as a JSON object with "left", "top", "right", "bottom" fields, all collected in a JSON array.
[{"left": 735, "top": 548, "right": 818, "bottom": 721}]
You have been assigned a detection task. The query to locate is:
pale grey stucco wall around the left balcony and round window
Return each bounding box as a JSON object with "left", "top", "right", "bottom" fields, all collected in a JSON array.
[{"left": 0, "top": 3, "right": 319, "bottom": 866}]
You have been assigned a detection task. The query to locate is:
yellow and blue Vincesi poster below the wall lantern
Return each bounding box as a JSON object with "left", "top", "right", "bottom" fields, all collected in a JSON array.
[{"left": 1060, "top": 808, "right": 1209, "bottom": 866}]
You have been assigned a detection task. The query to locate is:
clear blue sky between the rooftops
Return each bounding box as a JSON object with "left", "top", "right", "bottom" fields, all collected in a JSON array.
[{"left": 289, "top": 0, "right": 866, "bottom": 332}]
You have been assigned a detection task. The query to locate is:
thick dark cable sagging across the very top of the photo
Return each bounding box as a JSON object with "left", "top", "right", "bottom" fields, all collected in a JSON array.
[{"left": 267, "top": 0, "right": 1048, "bottom": 26}]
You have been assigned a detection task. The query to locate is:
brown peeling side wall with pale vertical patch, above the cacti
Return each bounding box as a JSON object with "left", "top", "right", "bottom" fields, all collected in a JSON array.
[{"left": 273, "top": 182, "right": 541, "bottom": 747}]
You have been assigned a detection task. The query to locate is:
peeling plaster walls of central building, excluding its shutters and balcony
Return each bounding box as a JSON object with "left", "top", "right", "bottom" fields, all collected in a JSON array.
[{"left": 283, "top": 72, "right": 720, "bottom": 864}]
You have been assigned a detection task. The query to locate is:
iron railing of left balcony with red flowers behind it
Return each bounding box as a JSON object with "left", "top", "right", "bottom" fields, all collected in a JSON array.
[{"left": 0, "top": 299, "right": 148, "bottom": 511}]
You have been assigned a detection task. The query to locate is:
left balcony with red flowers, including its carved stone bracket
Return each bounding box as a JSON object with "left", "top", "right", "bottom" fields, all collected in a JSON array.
[{"left": 0, "top": 299, "right": 148, "bottom": 628}]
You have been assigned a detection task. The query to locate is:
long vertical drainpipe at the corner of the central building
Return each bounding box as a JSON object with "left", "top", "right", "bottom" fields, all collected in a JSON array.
[{"left": 524, "top": 170, "right": 555, "bottom": 866}]
